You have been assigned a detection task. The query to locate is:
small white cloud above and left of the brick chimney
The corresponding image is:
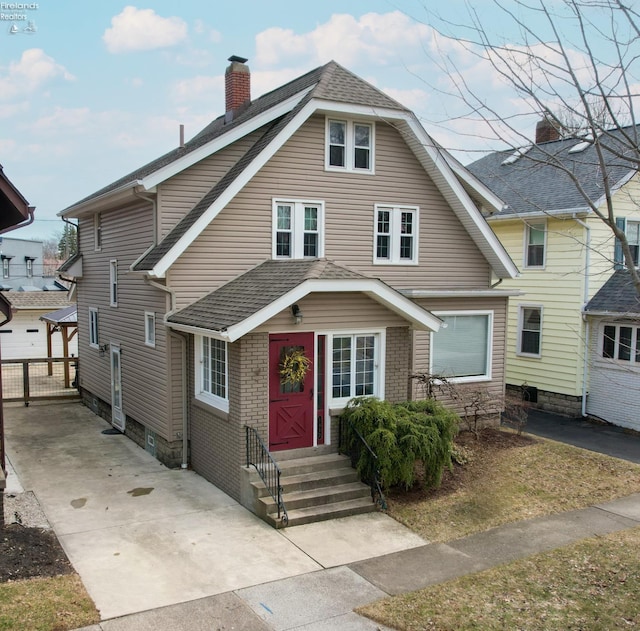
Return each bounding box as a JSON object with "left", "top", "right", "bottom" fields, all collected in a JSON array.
[{"left": 102, "top": 6, "right": 187, "bottom": 53}]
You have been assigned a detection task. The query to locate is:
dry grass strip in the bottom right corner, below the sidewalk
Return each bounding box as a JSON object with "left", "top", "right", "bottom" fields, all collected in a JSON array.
[{"left": 358, "top": 528, "right": 640, "bottom": 631}]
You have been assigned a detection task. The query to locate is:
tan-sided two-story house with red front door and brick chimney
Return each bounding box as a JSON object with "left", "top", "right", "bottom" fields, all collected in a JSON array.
[{"left": 61, "top": 57, "right": 517, "bottom": 524}]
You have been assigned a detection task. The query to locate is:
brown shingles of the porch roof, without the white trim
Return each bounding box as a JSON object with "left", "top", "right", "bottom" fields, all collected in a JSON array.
[{"left": 168, "top": 259, "right": 367, "bottom": 331}]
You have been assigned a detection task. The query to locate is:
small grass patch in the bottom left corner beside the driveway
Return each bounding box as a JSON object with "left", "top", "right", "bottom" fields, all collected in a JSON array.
[{"left": 0, "top": 574, "right": 100, "bottom": 631}]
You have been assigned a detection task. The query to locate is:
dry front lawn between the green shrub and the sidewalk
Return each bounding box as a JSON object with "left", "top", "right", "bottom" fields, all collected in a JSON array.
[{"left": 387, "top": 429, "right": 640, "bottom": 542}]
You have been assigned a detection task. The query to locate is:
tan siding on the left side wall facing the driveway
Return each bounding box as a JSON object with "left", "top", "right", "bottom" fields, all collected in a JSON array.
[{"left": 78, "top": 202, "right": 181, "bottom": 441}]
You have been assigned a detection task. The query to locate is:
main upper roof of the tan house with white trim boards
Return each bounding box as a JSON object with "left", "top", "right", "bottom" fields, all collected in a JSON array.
[{"left": 60, "top": 61, "right": 517, "bottom": 278}]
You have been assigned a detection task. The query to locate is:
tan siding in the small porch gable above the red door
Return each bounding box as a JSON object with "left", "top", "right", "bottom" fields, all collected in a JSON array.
[{"left": 255, "top": 292, "right": 407, "bottom": 333}]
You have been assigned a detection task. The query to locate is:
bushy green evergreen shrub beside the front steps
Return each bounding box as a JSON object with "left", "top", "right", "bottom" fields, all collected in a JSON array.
[{"left": 342, "top": 397, "right": 460, "bottom": 488}]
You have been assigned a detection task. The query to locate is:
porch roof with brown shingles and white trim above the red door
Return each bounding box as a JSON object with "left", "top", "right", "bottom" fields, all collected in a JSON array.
[{"left": 167, "top": 259, "right": 441, "bottom": 342}]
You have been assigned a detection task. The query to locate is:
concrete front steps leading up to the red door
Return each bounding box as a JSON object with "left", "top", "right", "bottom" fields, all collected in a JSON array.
[{"left": 252, "top": 453, "right": 377, "bottom": 528}]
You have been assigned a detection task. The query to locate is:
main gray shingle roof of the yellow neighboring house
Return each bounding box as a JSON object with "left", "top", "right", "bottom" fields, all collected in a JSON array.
[{"left": 467, "top": 126, "right": 640, "bottom": 221}]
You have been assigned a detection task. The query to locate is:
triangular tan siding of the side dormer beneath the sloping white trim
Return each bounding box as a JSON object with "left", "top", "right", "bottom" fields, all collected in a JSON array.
[{"left": 158, "top": 130, "right": 262, "bottom": 240}]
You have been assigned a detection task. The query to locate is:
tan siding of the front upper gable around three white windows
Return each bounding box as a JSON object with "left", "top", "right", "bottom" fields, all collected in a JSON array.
[{"left": 169, "top": 116, "right": 490, "bottom": 307}]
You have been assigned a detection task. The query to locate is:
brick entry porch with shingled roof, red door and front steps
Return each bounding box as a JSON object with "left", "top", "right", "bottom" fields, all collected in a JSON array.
[{"left": 168, "top": 261, "right": 440, "bottom": 525}]
